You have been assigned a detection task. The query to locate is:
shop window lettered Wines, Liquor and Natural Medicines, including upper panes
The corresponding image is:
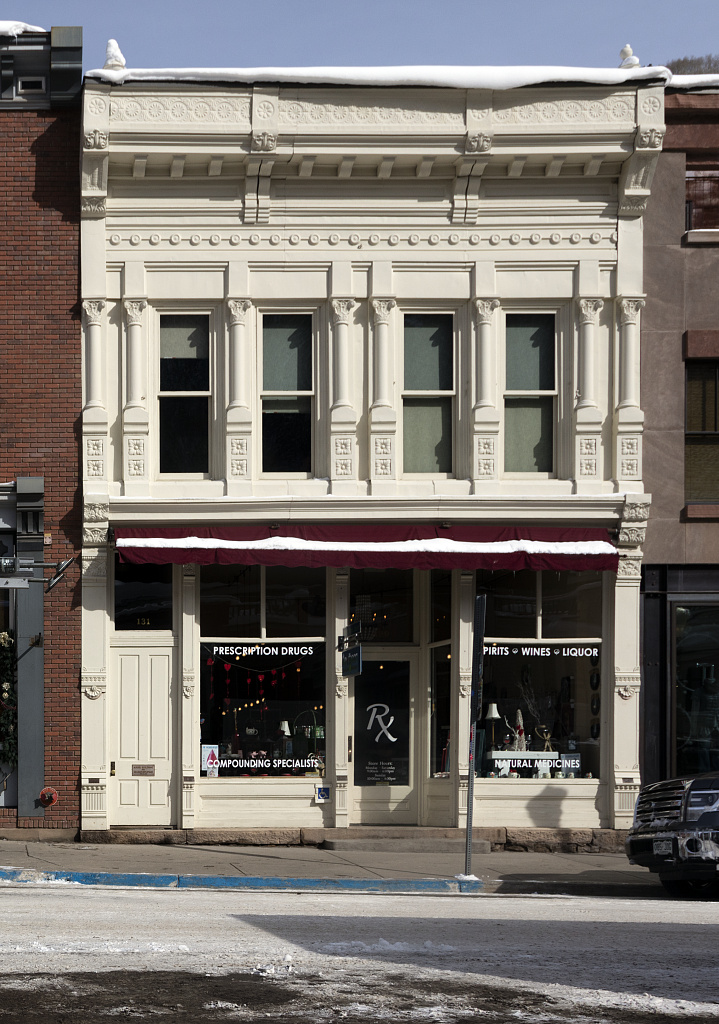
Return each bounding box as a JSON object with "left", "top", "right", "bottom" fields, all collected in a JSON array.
[{"left": 477, "top": 571, "right": 603, "bottom": 778}]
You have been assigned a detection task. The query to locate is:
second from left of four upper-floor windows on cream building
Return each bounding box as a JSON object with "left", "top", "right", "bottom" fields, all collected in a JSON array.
[{"left": 262, "top": 313, "right": 314, "bottom": 473}]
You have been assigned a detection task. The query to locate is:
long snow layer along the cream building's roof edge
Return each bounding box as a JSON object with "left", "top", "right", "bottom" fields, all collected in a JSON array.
[{"left": 86, "top": 65, "right": 675, "bottom": 89}]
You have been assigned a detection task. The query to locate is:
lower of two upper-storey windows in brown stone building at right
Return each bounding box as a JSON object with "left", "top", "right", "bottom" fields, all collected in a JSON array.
[{"left": 684, "top": 359, "right": 719, "bottom": 502}]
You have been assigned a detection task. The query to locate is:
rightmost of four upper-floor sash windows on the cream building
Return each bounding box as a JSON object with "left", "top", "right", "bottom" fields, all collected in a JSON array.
[{"left": 504, "top": 313, "right": 557, "bottom": 473}]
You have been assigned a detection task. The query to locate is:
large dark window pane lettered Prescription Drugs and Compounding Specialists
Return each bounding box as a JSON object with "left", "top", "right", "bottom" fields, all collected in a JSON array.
[{"left": 200, "top": 639, "right": 326, "bottom": 778}]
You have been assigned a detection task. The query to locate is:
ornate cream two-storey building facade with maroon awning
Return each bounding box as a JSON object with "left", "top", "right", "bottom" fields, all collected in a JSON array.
[{"left": 77, "top": 61, "right": 664, "bottom": 829}]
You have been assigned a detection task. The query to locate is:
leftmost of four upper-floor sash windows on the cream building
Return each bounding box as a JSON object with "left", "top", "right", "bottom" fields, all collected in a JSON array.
[{"left": 160, "top": 313, "right": 210, "bottom": 473}]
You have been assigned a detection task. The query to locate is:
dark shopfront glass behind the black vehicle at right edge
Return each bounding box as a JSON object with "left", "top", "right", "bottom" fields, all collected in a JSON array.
[{"left": 673, "top": 603, "right": 719, "bottom": 775}]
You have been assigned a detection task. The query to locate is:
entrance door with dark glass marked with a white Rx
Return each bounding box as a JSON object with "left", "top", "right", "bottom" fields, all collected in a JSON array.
[{"left": 349, "top": 650, "right": 419, "bottom": 824}]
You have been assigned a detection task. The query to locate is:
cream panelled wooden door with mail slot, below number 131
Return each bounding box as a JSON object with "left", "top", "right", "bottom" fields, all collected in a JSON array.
[{"left": 109, "top": 647, "right": 174, "bottom": 827}]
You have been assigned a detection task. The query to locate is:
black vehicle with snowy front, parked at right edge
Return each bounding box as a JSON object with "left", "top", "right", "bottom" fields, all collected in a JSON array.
[{"left": 626, "top": 772, "right": 719, "bottom": 899}]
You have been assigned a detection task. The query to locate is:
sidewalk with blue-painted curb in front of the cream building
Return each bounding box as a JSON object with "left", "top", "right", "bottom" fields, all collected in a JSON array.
[{"left": 0, "top": 839, "right": 663, "bottom": 899}]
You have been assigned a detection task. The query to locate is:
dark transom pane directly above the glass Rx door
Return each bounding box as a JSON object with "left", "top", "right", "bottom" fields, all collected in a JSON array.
[{"left": 349, "top": 569, "right": 414, "bottom": 643}]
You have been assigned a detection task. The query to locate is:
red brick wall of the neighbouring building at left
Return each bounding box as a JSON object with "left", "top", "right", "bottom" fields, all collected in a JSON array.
[{"left": 0, "top": 109, "right": 81, "bottom": 828}]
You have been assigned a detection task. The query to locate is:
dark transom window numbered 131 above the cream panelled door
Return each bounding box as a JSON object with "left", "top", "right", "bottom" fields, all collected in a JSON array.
[{"left": 115, "top": 555, "right": 172, "bottom": 630}]
